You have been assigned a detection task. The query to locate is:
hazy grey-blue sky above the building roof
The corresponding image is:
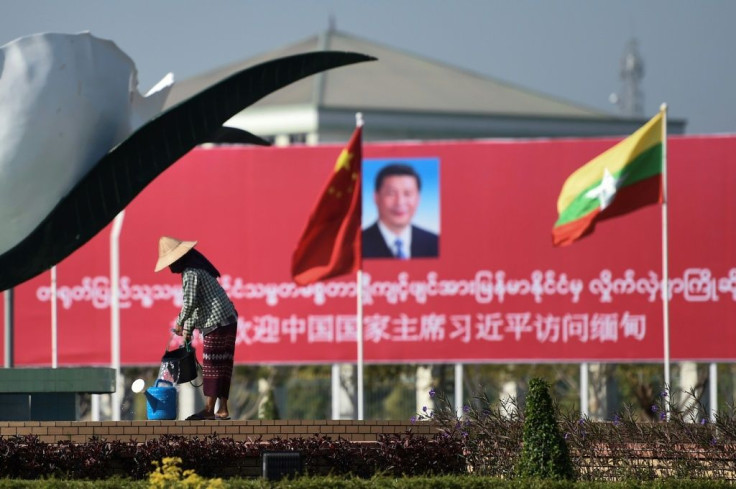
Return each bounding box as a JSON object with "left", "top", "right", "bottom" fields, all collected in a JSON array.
[{"left": 0, "top": 0, "right": 736, "bottom": 134}]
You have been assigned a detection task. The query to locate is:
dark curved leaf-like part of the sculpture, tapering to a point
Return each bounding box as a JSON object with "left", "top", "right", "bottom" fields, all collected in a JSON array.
[{"left": 0, "top": 51, "right": 375, "bottom": 290}]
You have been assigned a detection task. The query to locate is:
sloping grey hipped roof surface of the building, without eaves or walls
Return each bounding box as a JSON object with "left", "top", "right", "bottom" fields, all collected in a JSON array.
[{"left": 167, "top": 30, "right": 612, "bottom": 119}]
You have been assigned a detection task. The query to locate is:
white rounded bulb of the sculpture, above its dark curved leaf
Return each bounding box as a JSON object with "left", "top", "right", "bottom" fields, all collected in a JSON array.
[{"left": 0, "top": 33, "right": 173, "bottom": 254}]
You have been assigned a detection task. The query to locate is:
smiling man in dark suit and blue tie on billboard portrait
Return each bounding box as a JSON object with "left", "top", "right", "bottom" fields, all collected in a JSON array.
[{"left": 362, "top": 163, "right": 439, "bottom": 259}]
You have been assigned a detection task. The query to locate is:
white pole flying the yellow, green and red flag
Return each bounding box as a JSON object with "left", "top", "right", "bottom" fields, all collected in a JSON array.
[{"left": 659, "top": 104, "right": 672, "bottom": 421}]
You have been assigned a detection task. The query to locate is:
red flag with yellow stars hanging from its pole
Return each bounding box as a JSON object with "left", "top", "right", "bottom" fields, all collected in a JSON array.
[{"left": 291, "top": 126, "right": 363, "bottom": 285}]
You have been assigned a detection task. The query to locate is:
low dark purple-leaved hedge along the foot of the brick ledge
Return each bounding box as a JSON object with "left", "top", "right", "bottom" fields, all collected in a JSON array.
[{"left": 0, "top": 432, "right": 467, "bottom": 480}]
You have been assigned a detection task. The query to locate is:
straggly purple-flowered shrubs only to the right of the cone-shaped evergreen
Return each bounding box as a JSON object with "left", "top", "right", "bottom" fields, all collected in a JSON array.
[{"left": 560, "top": 388, "right": 736, "bottom": 481}]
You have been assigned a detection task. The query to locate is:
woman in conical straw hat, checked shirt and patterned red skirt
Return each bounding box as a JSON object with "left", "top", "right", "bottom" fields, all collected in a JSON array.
[{"left": 155, "top": 236, "right": 238, "bottom": 420}]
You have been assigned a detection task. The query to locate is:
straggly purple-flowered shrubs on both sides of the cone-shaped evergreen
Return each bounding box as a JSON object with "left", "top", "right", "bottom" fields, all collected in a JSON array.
[{"left": 412, "top": 378, "right": 736, "bottom": 483}]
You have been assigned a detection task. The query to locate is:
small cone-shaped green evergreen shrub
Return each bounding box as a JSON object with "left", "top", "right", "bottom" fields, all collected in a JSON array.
[{"left": 516, "top": 378, "right": 575, "bottom": 480}]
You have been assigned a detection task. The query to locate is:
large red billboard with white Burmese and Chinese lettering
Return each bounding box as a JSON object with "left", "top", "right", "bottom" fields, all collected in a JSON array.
[{"left": 0, "top": 136, "right": 736, "bottom": 366}]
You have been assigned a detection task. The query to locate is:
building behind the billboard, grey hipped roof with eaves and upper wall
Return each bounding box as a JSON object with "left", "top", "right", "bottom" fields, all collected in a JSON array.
[{"left": 166, "top": 28, "right": 685, "bottom": 140}]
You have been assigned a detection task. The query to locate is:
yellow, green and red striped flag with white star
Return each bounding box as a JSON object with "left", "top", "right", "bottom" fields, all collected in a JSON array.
[{"left": 552, "top": 110, "right": 665, "bottom": 246}]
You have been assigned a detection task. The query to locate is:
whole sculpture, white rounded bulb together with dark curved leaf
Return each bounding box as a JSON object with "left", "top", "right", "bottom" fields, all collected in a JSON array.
[{"left": 0, "top": 33, "right": 375, "bottom": 291}]
